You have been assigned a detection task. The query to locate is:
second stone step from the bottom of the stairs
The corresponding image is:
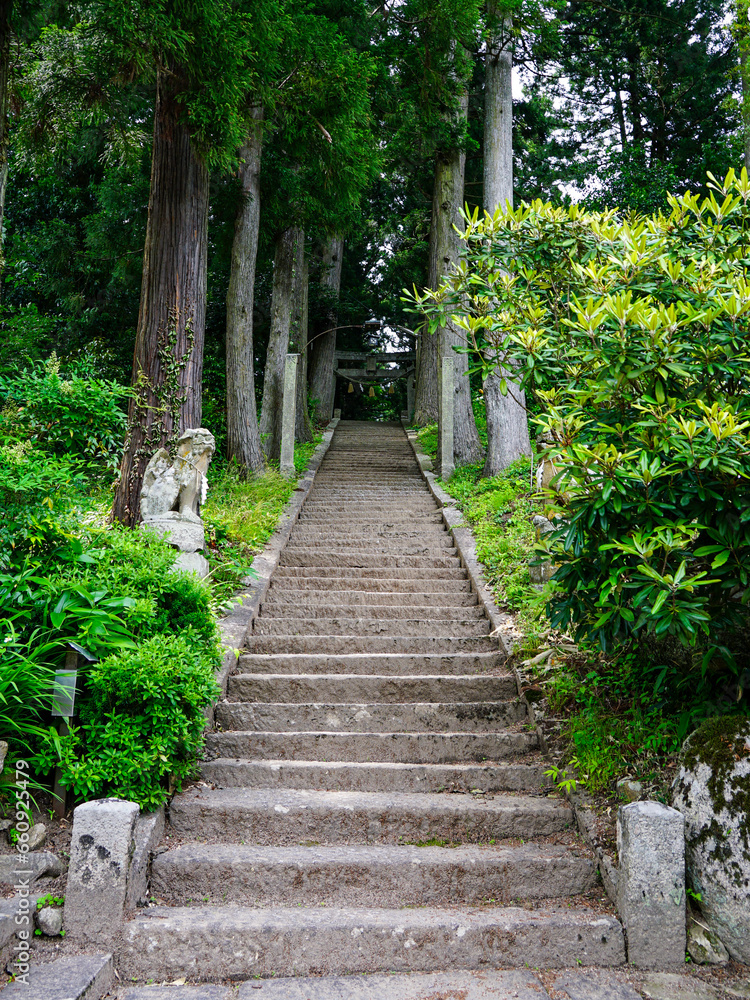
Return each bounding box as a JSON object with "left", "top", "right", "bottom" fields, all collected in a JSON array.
[{"left": 151, "top": 844, "right": 597, "bottom": 909}]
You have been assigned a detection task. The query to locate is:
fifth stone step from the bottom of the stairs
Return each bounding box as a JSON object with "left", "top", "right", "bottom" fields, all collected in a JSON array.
[{"left": 206, "top": 731, "right": 539, "bottom": 764}]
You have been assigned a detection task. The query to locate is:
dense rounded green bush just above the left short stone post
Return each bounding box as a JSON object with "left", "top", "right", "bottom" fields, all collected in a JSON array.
[{"left": 34, "top": 630, "right": 219, "bottom": 810}]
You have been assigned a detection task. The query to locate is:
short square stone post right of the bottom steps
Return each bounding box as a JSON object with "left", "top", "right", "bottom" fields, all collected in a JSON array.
[{"left": 617, "top": 802, "right": 686, "bottom": 969}]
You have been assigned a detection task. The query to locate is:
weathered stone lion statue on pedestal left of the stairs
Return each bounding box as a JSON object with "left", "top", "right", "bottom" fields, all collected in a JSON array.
[{"left": 141, "top": 427, "right": 216, "bottom": 576}]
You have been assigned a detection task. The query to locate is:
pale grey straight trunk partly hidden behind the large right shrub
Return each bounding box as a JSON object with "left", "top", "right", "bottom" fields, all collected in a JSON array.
[{"left": 483, "top": 7, "right": 531, "bottom": 477}]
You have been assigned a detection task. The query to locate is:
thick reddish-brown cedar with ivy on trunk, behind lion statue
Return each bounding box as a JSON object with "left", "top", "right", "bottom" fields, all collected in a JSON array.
[{"left": 92, "top": 0, "right": 263, "bottom": 525}]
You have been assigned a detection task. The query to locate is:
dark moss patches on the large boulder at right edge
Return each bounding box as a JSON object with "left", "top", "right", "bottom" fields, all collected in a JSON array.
[{"left": 678, "top": 715, "right": 750, "bottom": 875}]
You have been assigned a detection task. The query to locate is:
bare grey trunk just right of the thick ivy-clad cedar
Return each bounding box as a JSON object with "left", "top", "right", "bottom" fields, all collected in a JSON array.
[{"left": 226, "top": 107, "right": 263, "bottom": 472}]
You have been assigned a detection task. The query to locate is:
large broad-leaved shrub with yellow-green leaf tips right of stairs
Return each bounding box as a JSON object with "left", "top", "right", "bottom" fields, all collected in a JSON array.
[{"left": 416, "top": 170, "right": 750, "bottom": 696}]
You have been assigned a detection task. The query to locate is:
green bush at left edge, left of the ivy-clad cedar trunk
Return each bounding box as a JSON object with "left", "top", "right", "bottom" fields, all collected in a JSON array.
[{"left": 0, "top": 354, "right": 129, "bottom": 470}]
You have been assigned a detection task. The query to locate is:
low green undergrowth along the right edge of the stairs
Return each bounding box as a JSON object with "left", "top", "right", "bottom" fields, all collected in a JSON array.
[{"left": 418, "top": 424, "right": 719, "bottom": 801}]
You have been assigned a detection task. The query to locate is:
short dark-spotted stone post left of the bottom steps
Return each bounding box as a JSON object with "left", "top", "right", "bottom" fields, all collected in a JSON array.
[{"left": 65, "top": 799, "right": 139, "bottom": 949}]
